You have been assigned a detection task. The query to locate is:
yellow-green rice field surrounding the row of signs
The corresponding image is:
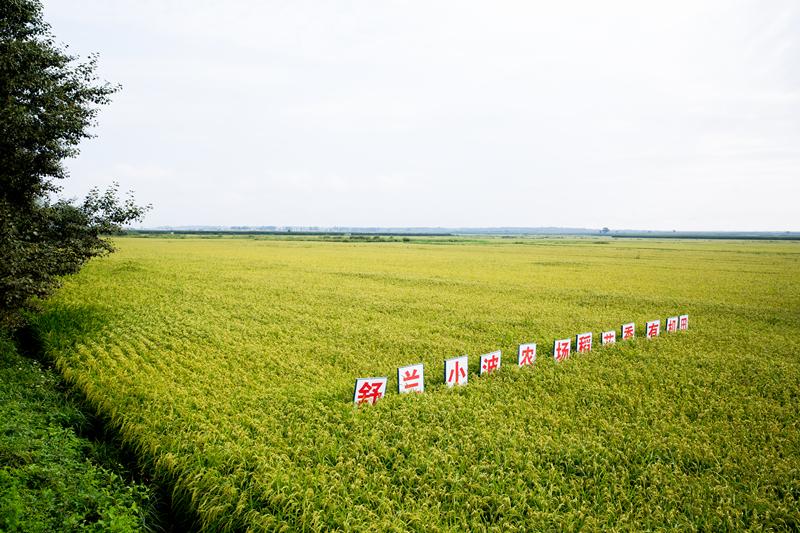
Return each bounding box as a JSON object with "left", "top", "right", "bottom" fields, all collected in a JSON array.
[{"left": 32, "top": 238, "right": 800, "bottom": 531}]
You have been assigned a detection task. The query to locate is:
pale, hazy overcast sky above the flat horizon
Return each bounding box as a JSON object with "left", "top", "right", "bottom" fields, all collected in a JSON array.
[{"left": 43, "top": 0, "right": 800, "bottom": 231}]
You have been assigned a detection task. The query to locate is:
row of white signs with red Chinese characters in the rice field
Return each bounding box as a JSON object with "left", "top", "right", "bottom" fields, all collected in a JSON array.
[{"left": 353, "top": 315, "right": 689, "bottom": 405}]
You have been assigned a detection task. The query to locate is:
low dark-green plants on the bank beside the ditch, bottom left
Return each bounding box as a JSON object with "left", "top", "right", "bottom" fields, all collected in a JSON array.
[{"left": 0, "top": 336, "right": 152, "bottom": 533}]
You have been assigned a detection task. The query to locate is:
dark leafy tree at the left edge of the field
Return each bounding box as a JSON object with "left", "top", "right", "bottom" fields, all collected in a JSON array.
[{"left": 0, "top": 0, "right": 150, "bottom": 329}]
